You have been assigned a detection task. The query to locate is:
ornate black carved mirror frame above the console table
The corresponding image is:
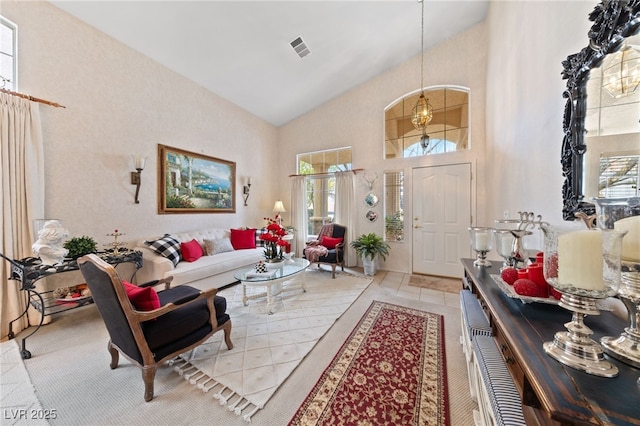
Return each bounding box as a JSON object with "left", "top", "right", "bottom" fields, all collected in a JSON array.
[{"left": 561, "top": 0, "right": 640, "bottom": 220}]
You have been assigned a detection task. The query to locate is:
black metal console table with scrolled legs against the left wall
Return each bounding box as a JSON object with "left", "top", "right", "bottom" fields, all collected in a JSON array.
[{"left": 0, "top": 250, "right": 142, "bottom": 359}]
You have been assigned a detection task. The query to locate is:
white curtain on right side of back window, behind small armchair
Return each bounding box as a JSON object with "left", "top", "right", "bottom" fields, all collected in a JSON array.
[{"left": 335, "top": 172, "right": 358, "bottom": 267}]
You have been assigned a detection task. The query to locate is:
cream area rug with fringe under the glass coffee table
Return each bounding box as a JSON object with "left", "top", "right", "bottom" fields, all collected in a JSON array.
[{"left": 174, "top": 271, "right": 372, "bottom": 422}]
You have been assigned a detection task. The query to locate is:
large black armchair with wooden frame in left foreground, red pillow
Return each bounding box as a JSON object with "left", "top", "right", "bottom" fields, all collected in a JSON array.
[{"left": 78, "top": 254, "right": 233, "bottom": 401}]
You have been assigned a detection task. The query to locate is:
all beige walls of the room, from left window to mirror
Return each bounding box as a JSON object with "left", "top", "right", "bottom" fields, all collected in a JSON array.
[{"left": 0, "top": 0, "right": 596, "bottom": 271}]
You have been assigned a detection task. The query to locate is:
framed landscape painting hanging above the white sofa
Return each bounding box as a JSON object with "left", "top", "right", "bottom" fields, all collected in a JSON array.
[{"left": 158, "top": 144, "right": 236, "bottom": 214}]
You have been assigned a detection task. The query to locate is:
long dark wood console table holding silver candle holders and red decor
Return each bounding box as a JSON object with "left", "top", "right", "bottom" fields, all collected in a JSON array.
[{"left": 462, "top": 259, "right": 640, "bottom": 425}]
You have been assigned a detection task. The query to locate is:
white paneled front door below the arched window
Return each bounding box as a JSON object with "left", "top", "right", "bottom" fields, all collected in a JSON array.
[{"left": 412, "top": 163, "right": 471, "bottom": 277}]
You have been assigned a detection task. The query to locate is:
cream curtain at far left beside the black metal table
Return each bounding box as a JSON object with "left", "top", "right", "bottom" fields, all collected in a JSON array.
[{"left": 0, "top": 92, "right": 44, "bottom": 340}]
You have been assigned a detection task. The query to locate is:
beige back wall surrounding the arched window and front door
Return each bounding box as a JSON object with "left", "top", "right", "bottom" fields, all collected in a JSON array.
[{"left": 278, "top": 24, "right": 487, "bottom": 272}]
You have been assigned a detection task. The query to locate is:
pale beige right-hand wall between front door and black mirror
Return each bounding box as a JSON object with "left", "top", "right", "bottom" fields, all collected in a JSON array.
[{"left": 483, "top": 0, "right": 597, "bottom": 251}]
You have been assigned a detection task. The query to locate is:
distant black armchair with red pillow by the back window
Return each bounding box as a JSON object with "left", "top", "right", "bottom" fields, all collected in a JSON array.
[{"left": 302, "top": 223, "right": 347, "bottom": 278}]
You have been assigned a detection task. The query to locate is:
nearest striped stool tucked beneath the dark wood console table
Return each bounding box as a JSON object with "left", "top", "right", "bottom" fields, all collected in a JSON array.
[{"left": 473, "top": 336, "right": 527, "bottom": 426}]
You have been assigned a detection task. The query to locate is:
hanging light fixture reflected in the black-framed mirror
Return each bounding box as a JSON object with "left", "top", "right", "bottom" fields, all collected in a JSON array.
[{"left": 602, "top": 44, "right": 640, "bottom": 99}]
